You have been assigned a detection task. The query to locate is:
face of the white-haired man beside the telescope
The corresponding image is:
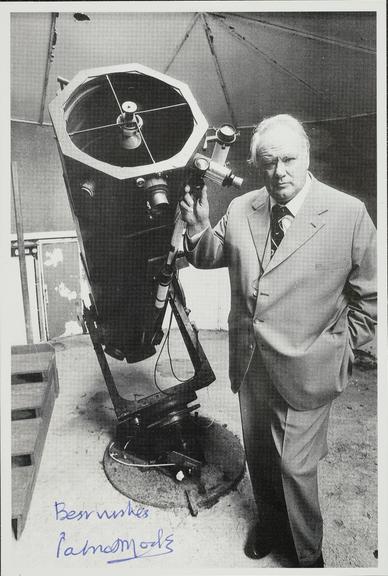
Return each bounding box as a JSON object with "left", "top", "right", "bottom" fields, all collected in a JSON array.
[{"left": 257, "top": 125, "right": 309, "bottom": 204}]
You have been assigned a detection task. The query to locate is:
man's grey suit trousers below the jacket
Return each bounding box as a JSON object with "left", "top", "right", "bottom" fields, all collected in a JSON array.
[{"left": 239, "top": 350, "right": 331, "bottom": 566}]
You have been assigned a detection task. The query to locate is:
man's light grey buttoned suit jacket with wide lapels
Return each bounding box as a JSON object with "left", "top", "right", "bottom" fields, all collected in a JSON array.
[{"left": 186, "top": 178, "right": 377, "bottom": 410}]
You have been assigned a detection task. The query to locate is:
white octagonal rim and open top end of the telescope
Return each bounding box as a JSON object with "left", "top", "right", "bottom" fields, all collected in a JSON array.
[{"left": 49, "top": 64, "right": 208, "bottom": 180}]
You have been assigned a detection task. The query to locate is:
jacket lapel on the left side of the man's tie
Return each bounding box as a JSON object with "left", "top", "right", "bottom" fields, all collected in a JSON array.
[{"left": 247, "top": 193, "right": 271, "bottom": 271}]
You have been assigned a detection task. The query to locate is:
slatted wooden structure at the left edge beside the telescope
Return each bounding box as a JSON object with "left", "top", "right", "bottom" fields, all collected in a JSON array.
[{"left": 11, "top": 343, "right": 59, "bottom": 538}]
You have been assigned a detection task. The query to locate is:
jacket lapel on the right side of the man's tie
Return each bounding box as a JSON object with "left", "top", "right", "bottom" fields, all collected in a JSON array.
[{"left": 265, "top": 179, "right": 328, "bottom": 274}]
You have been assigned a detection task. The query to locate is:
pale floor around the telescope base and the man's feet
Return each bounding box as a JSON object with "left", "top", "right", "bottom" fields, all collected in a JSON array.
[{"left": 7, "top": 331, "right": 377, "bottom": 576}]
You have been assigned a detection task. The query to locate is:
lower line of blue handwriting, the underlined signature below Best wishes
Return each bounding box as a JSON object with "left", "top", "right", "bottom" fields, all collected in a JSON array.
[{"left": 56, "top": 528, "right": 174, "bottom": 564}]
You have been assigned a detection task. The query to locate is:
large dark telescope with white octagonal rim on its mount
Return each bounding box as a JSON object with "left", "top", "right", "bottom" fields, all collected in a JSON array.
[{"left": 49, "top": 64, "right": 241, "bottom": 504}]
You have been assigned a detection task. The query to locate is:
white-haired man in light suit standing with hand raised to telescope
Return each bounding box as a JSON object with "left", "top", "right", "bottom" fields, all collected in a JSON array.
[{"left": 181, "top": 115, "right": 376, "bottom": 567}]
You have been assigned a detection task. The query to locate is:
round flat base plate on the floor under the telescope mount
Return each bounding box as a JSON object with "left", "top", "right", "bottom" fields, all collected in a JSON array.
[{"left": 103, "top": 417, "right": 245, "bottom": 516}]
